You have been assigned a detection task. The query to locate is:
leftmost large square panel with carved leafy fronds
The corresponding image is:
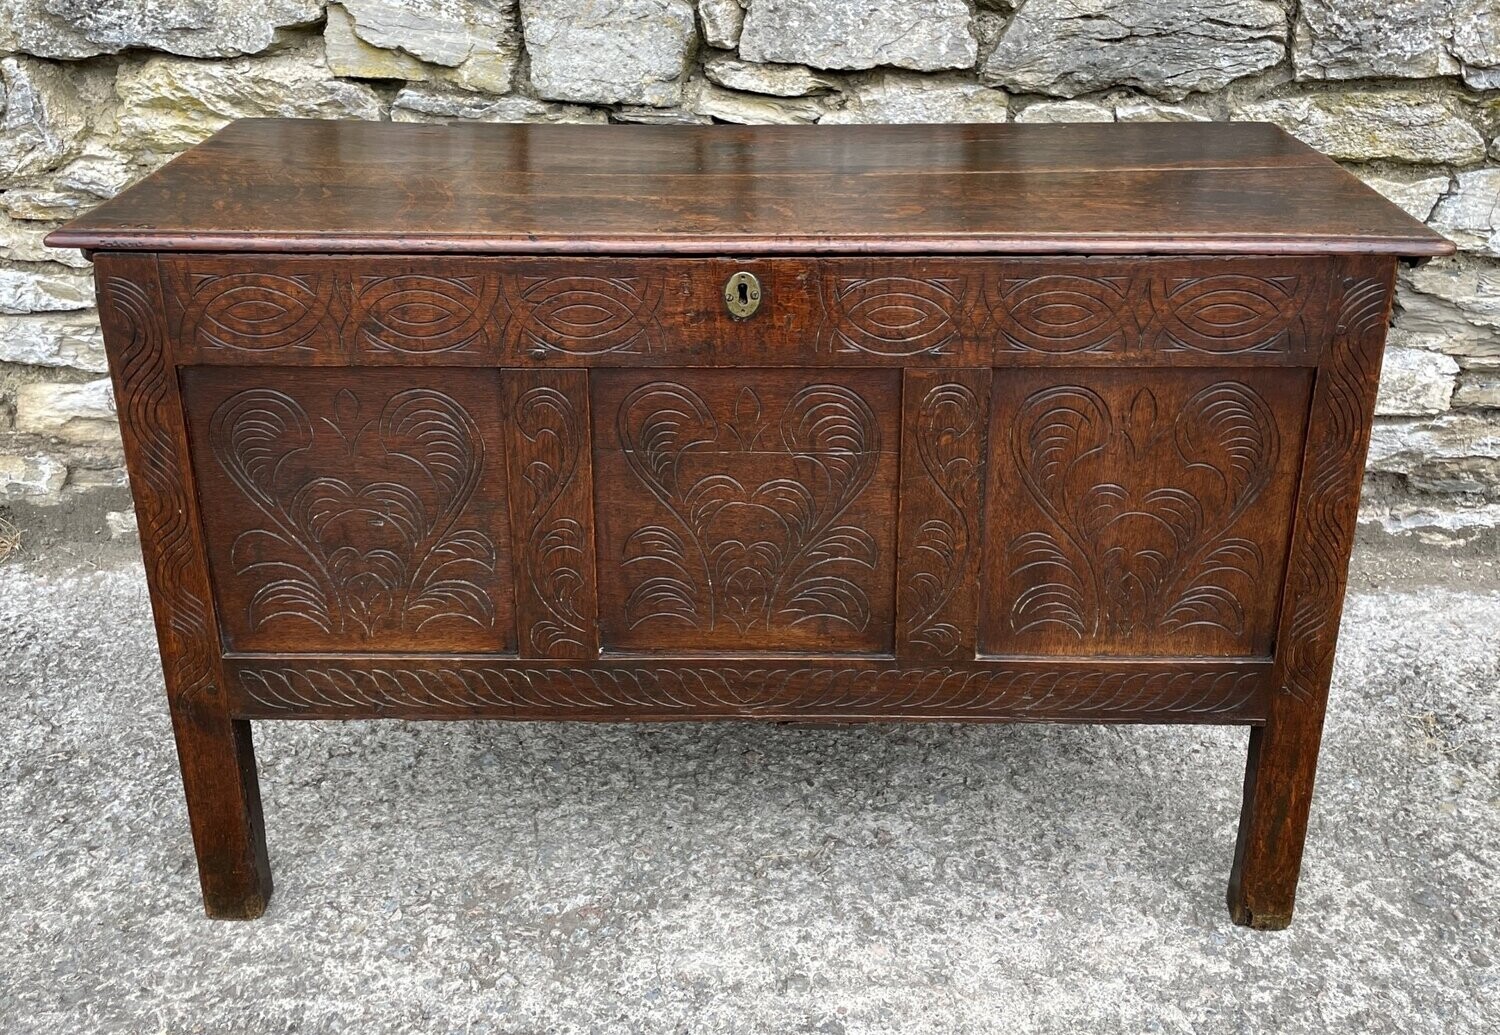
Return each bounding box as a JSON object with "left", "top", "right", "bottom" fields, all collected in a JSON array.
[{"left": 183, "top": 368, "right": 513, "bottom": 651}]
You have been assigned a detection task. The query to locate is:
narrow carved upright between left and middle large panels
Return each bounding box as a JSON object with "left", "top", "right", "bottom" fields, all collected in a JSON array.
[{"left": 507, "top": 371, "right": 599, "bottom": 659}]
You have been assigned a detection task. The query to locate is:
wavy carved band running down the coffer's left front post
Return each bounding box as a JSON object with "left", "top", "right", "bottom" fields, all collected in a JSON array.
[{"left": 99, "top": 260, "right": 218, "bottom": 702}]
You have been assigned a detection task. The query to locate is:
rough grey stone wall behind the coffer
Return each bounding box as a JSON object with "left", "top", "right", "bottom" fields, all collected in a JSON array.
[{"left": 0, "top": 0, "right": 1500, "bottom": 524}]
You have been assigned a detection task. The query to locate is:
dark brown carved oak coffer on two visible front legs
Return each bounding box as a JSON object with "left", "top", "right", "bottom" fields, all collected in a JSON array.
[{"left": 50, "top": 120, "right": 1449, "bottom": 927}]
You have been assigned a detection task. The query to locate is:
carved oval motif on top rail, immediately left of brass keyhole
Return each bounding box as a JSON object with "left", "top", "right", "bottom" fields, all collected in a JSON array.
[{"left": 506, "top": 275, "right": 662, "bottom": 356}]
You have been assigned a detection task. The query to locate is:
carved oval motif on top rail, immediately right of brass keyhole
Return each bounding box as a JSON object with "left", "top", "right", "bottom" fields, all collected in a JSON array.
[{"left": 818, "top": 275, "right": 969, "bottom": 356}]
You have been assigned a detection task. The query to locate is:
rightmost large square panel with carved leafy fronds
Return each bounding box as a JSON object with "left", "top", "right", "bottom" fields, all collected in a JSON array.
[{"left": 984, "top": 371, "right": 1310, "bottom": 656}]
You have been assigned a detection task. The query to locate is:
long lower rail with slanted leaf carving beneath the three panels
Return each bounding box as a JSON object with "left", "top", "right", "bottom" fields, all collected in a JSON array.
[{"left": 225, "top": 656, "right": 1271, "bottom": 725}]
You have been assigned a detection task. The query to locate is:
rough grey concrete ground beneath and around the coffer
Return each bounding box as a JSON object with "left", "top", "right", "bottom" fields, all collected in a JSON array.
[{"left": 0, "top": 528, "right": 1500, "bottom": 1035}]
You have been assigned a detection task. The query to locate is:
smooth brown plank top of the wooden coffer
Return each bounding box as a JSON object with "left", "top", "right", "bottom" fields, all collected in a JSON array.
[{"left": 48, "top": 119, "right": 1454, "bottom": 257}]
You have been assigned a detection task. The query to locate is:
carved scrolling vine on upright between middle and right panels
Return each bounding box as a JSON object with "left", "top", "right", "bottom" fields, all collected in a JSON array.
[{"left": 903, "top": 383, "right": 986, "bottom": 657}]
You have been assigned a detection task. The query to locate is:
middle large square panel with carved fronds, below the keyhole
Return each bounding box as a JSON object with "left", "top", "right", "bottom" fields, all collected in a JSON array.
[{"left": 593, "top": 371, "right": 900, "bottom": 651}]
